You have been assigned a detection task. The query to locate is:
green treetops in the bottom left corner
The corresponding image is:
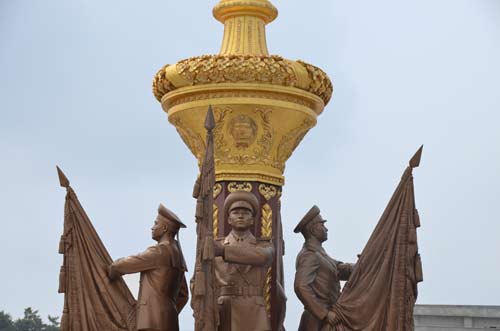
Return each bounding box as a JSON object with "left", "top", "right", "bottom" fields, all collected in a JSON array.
[{"left": 0, "top": 307, "right": 60, "bottom": 331}]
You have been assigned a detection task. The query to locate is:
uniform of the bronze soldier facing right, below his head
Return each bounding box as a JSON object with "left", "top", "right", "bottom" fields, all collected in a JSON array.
[{"left": 294, "top": 242, "right": 353, "bottom": 331}]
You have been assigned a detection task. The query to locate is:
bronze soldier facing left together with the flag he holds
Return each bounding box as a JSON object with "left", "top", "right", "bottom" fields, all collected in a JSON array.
[{"left": 57, "top": 168, "right": 188, "bottom": 331}]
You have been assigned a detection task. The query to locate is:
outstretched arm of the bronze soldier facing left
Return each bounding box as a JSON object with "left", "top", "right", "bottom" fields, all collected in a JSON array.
[{"left": 109, "top": 247, "right": 160, "bottom": 279}]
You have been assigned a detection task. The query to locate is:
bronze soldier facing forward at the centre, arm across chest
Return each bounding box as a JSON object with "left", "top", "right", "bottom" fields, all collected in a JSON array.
[{"left": 211, "top": 192, "right": 274, "bottom": 331}]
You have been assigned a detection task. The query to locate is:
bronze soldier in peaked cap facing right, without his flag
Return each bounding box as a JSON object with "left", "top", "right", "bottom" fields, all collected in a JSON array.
[{"left": 293, "top": 206, "right": 353, "bottom": 331}]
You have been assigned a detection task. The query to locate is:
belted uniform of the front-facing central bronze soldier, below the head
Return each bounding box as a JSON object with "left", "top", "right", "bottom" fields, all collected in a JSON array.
[{"left": 215, "top": 232, "right": 274, "bottom": 331}]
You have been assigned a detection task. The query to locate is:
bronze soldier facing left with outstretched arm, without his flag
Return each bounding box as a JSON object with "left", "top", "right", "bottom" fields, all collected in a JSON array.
[{"left": 109, "top": 204, "right": 188, "bottom": 331}]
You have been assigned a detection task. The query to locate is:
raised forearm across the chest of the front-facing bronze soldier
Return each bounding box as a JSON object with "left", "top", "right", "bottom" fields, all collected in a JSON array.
[{"left": 224, "top": 245, "right": 274, "bottom": 266}]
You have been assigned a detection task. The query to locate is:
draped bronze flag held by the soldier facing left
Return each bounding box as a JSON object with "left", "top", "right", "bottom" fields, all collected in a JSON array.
[{"left": 57, "top": 167, "right": 136, "bottom": 331}]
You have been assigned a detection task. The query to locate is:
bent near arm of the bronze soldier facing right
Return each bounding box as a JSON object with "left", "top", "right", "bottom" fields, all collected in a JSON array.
[{"left": 294, "top": 252, "right": 328, "bottom": 321}]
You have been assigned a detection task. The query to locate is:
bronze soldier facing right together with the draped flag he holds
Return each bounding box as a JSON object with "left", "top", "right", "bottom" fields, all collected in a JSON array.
[{"left": 295, "top": 147, "right": 423, "bottom": 331}]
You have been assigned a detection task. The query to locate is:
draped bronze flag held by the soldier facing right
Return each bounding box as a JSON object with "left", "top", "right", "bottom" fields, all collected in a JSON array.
[{"left": 333, "top": 147, "right": 423, "bottom": 331}]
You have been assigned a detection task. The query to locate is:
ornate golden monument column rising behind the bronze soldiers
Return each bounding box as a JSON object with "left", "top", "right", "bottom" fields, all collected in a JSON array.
[{"left": 153, "top": 0, "right": 333, "bottom": 330}]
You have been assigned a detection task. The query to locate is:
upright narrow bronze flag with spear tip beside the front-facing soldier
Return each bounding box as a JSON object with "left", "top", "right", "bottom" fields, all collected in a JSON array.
[{"left": 191, "top": 107, "right": 219, "bottom": 331}]
